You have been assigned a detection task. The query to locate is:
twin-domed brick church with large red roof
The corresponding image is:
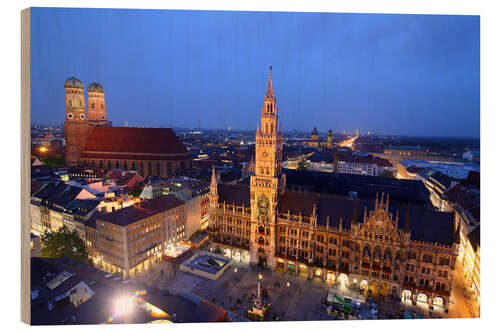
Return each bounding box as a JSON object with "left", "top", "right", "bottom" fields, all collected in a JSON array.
[{"left": 64, "top": 77, "right": 191, "bottom": 177}]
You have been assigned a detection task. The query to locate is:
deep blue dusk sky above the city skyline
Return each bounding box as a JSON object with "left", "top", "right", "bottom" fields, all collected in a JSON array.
[{"left": 31, "top": 8, "right": 480, "bottom": 137}]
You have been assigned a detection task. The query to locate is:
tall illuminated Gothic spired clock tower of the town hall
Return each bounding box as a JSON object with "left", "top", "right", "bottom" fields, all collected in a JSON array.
[{"left": 250, "top": 66, "right": 285, "bottom": 268}]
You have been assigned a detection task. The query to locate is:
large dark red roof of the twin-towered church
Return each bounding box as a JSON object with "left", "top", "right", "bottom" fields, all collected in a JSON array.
[{"left": 82, "top": 126, "right": 188, "bottom": 159}]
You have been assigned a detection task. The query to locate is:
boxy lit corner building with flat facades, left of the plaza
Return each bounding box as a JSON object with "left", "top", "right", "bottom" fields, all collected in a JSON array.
[{"left": 86, "top": 195, "right": 186, "bottom": 278}]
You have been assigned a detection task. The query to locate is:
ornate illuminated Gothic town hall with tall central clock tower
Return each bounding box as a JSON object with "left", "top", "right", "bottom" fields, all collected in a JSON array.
[{"left": 207, "top": 67, "right": 459, "bottom": 308}]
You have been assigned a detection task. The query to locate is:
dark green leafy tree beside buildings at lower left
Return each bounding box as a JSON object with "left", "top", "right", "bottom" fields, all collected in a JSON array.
[{"left": 41, "top": 226, "right": 89, "bottom": 263}]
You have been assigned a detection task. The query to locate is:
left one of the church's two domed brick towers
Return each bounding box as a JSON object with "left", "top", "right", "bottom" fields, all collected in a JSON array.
[{"left": 64, "top": 77, "right": 89, "bottom": 165}]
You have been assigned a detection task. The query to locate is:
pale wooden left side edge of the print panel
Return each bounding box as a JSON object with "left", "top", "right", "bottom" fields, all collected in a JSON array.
[{"left": 21, "top": 8, "right": 31, "bottom": 324}]
